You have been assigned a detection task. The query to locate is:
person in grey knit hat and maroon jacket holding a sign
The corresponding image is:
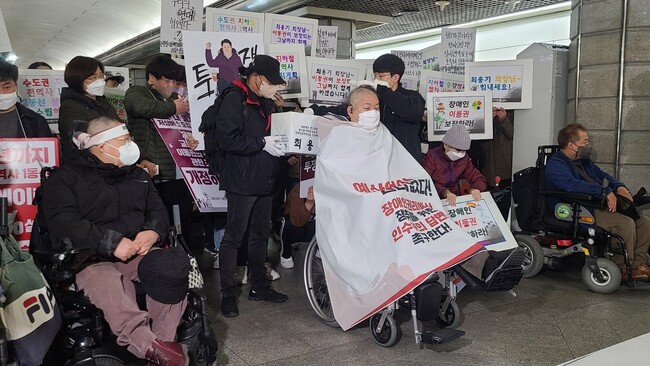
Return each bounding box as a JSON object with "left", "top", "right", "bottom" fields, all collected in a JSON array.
[{"left": 422, "top": 125, "right": 487, "bottom": 206}]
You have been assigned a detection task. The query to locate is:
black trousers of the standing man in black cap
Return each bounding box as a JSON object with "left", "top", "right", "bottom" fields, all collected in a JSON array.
[{"left": 219, "top": 192, "right": 273, "bottom": 296}]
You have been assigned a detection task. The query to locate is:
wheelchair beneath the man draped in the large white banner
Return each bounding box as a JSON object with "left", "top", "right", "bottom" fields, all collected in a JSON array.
[{"left": 303, "top": 237, "right": 524, "bottom": 347}]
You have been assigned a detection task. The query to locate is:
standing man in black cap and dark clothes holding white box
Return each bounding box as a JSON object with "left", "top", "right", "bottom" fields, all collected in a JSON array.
[{"left": 211, "top": 55, "right": 288, "bottom": 317}]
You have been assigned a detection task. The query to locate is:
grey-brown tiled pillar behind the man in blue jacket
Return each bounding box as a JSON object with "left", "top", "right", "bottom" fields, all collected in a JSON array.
[{"left": 567, "top": 0, "right": 650, "bottom": 193}]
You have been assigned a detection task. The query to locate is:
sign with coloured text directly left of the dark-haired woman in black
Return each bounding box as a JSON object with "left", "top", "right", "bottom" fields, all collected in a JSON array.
[{"left": 18, "top": 70, "right": 68, "bottom": 133}]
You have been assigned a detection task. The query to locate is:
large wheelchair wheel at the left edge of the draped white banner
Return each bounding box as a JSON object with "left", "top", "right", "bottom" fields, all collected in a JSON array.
[{"left": 303, "top": 238, "right": 339, "bottom": 328}]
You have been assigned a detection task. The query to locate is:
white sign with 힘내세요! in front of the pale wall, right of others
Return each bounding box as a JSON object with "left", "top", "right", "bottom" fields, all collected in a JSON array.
[{"left": 465, "top": 59, "right": 533, "bottom": 109}]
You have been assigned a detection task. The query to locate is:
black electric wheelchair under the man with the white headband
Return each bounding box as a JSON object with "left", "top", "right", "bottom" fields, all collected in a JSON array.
[{"left": 21, "top": 168, "right": 218, "bottom": 366}]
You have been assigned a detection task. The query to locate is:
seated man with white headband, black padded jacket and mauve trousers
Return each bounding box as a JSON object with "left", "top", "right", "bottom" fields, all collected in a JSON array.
[{"left": 42, "top": 117, "right": 187, "bottom": 366}]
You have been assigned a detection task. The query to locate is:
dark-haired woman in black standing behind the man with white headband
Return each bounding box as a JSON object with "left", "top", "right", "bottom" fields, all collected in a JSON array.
[{"left": 59, "top": 56, "right": 120, "bottom": 163}]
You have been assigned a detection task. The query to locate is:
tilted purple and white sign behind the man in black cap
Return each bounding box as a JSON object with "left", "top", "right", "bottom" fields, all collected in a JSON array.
[{"left": 153, "top": 115, "right": 227, "bottom": 212}]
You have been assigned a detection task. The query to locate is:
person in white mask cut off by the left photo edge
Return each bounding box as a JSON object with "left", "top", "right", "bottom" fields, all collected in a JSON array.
[{"left": 0, "top": 60, "right": 52, "bottom": 137}]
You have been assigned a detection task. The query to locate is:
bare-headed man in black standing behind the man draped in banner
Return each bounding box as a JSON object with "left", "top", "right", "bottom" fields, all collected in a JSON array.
[{"left": 372, "top": 53, "right": 425, "bottom": 162}]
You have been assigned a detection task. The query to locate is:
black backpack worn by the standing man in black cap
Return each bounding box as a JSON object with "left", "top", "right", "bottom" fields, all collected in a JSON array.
[{"left": 199, "top": 86, "right": 248, "bottom": 177}]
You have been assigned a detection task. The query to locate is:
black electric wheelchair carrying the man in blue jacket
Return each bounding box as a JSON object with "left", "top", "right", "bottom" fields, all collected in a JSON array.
[{"left": 512, "top": 145, "right": 646, "bottom": 294}]
